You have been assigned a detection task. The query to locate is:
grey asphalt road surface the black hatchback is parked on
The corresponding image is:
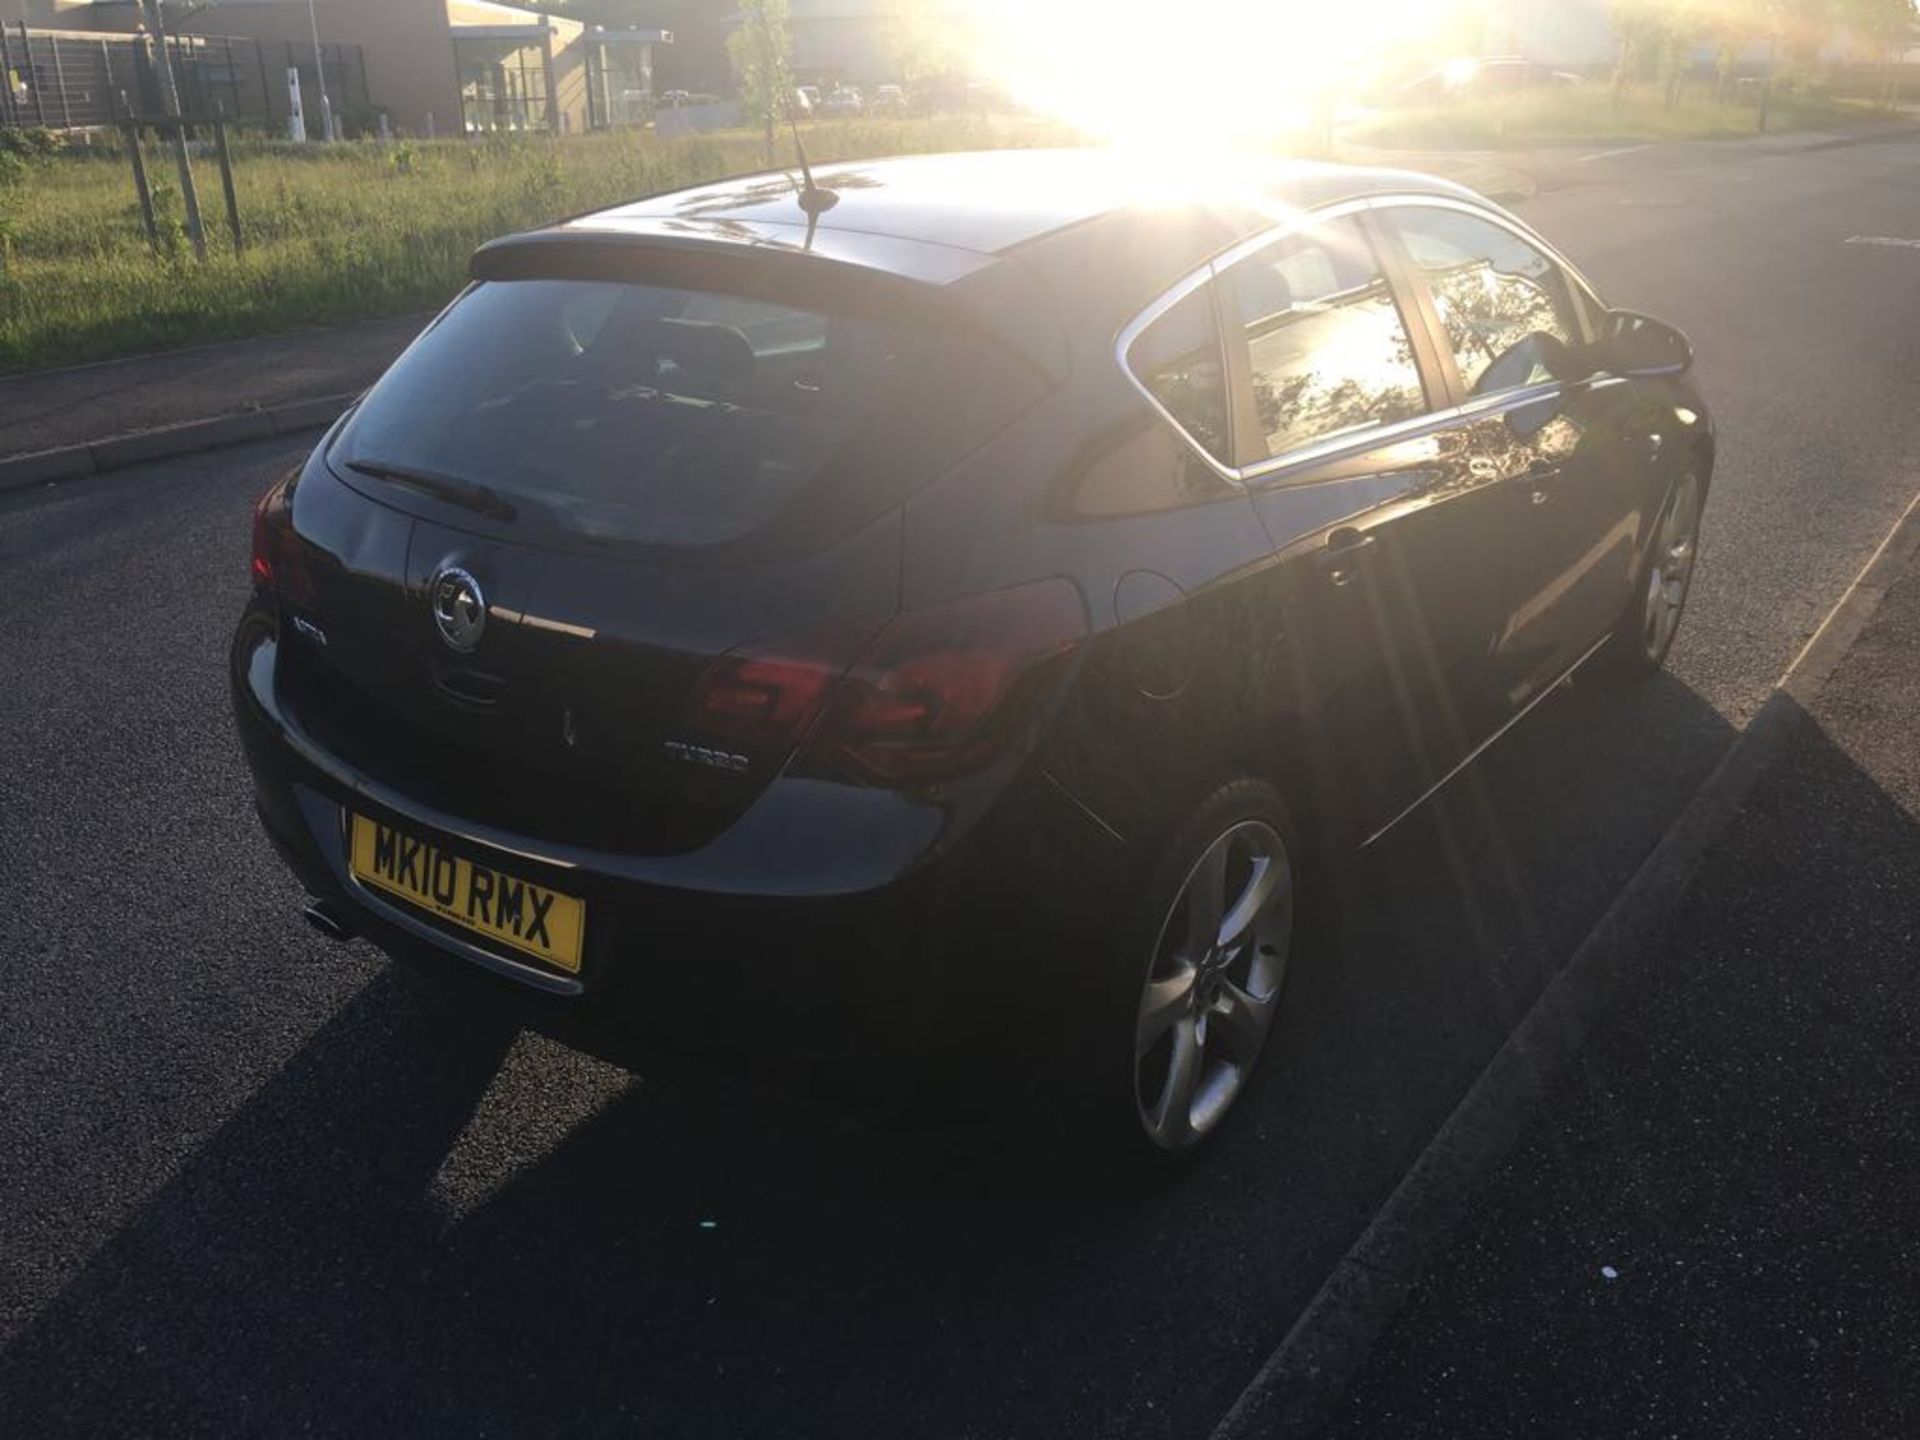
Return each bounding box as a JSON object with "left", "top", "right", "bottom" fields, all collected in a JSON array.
[{"left": 11, "top": 129, "right": 1920, "bottom": 1438}]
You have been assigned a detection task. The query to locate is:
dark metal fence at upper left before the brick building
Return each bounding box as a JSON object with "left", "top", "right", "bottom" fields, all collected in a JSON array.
[{"left": 0, "top": 25, "right": 372, "bottom": 131}]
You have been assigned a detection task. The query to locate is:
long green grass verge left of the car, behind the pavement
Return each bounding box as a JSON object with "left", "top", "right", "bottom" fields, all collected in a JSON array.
[{"left": 0, "top": 115, "right": 1071, "bottom": 371}]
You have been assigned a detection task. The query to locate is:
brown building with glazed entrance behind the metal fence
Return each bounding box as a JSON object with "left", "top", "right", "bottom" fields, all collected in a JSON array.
[{"left": 11, "top": 0, "right": 672, "bottom": 134}]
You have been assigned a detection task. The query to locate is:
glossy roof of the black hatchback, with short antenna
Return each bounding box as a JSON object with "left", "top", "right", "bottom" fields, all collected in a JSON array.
[{"left": 472, "top": 150, "right": 1478, "bottom": 384}]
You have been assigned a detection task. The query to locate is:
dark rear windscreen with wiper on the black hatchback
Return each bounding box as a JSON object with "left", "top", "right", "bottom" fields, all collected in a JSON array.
[{"left": 328, "top": 278, "right": 1041, "bottom": 547}]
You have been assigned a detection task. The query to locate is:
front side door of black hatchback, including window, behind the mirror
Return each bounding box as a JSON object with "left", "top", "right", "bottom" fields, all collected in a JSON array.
[{"left": 1379, "top": 202, "right": 1651, "bottom": 708}]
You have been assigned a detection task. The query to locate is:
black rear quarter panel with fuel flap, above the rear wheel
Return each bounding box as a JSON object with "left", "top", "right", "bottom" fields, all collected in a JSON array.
[{"left": 902, "top": 337, "right": 1288, "bottom": 852}]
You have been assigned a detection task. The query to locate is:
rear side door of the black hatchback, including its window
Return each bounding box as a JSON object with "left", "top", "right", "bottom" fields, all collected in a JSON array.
[{"left": 1215, "top": 211, "right": 1509, "bottom": 833}]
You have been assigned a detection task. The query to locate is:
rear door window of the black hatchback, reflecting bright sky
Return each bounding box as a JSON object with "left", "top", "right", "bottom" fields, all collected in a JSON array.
[{"left": 1219, "top": 219, "right": 1427, "bottom": 459}]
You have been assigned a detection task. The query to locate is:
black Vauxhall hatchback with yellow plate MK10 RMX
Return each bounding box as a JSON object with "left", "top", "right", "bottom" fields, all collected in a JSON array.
[{"left": 232, "top": 152, "right": 1713, "bottom": 1156}]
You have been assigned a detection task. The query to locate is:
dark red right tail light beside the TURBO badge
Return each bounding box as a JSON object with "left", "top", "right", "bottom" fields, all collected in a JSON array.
[{"left": 693, "top": 580, "right": 1087, "bottom": 785}]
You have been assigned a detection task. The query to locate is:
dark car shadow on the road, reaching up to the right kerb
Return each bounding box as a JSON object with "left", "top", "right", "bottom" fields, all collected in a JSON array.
[{"left": 0, "top": 678, "right": 1797, "bottom": 1436}]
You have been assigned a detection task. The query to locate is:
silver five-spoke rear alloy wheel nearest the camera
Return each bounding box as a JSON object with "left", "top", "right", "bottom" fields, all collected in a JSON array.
[{"left": 1133, "top": 820, "right": 1294, "bottom": 1150}]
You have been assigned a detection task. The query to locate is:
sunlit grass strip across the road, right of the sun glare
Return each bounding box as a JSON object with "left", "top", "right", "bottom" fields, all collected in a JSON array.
[{"left": 1342, "top": 84, "right": 1880, "bottom": 150}]
